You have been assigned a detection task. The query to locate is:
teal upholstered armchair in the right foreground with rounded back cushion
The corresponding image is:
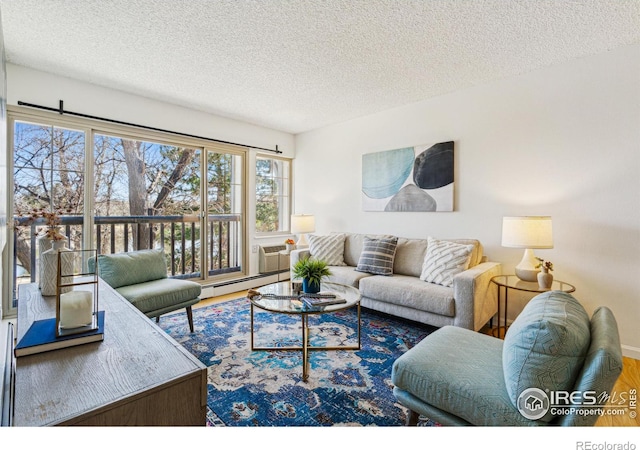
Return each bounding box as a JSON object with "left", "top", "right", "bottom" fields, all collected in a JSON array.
[{"left": 391, "top": 291, "right": 622, "bottom": 426}]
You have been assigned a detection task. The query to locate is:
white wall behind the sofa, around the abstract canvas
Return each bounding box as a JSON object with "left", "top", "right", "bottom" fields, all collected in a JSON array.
[{"left": 294, "top": 45, "right": 640, "bottom": 358}]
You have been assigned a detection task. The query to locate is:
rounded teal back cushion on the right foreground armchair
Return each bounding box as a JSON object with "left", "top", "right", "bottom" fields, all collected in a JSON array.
[{"left": 502, "top": 291, "right": 591, "bottom": 422}]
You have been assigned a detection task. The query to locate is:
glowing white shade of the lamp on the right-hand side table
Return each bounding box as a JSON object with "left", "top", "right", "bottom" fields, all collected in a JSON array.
[{"left": 502, "top": 216, "right": 553, "bottom": 248}]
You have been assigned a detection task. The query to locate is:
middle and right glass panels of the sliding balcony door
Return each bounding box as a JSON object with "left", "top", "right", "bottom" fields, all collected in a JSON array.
[{"left": 94, "top": 134, "right": 245, "bottom": 281}]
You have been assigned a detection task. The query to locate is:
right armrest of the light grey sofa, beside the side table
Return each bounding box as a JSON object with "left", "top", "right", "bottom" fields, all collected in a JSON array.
[{"left": 453, "top": 262, "right": 502, "bottom": 331}]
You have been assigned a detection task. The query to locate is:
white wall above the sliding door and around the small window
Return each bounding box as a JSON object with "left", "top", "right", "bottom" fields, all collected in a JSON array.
[{"left": 7, "top": 64, "right": 295, "bottom": 288}]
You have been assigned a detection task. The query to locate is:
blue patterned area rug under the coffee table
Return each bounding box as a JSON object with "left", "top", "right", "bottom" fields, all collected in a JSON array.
[{"left": 160, "top": 298, "right": 435, "bottom": 426}]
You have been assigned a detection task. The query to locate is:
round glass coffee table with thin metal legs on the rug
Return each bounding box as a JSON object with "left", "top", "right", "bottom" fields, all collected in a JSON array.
[{"left": 247, "top": 281, "right": 361, "bottom": 381}]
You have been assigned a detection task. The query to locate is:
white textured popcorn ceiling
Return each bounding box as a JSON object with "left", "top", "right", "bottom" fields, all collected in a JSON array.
[{"left": 0, "top": 0, "right": 640, "bottom": 133}]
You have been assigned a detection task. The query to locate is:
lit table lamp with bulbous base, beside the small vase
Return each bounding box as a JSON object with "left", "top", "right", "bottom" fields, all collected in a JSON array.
[{"left": 502, "top": 216, "right": 553, "bottom": 281}]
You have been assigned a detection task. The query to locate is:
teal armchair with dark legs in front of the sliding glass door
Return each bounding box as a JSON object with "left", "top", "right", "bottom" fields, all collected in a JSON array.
[{"left": 90, "top": 250, "right": 202, "bottom": 333}]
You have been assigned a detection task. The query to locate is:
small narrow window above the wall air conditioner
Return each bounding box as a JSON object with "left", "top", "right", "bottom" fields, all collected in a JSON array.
[{"left": 256, "top": 156, "right": 291, "bottom": 234}]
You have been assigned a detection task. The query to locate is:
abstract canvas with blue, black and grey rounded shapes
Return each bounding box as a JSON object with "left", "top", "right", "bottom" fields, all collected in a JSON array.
[{"left": 362, "top": 141, "right": 454, "bottom": 212}]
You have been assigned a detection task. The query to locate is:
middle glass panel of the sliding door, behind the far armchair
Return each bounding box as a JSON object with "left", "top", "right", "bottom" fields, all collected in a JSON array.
[{"left": 93, "top": 134, "right": 202, "bottom": 278}]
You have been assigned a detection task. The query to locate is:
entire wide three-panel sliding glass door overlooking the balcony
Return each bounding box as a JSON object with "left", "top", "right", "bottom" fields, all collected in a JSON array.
[{"left": 3, "top": 108, "right": 250, "bottom": 314}]
